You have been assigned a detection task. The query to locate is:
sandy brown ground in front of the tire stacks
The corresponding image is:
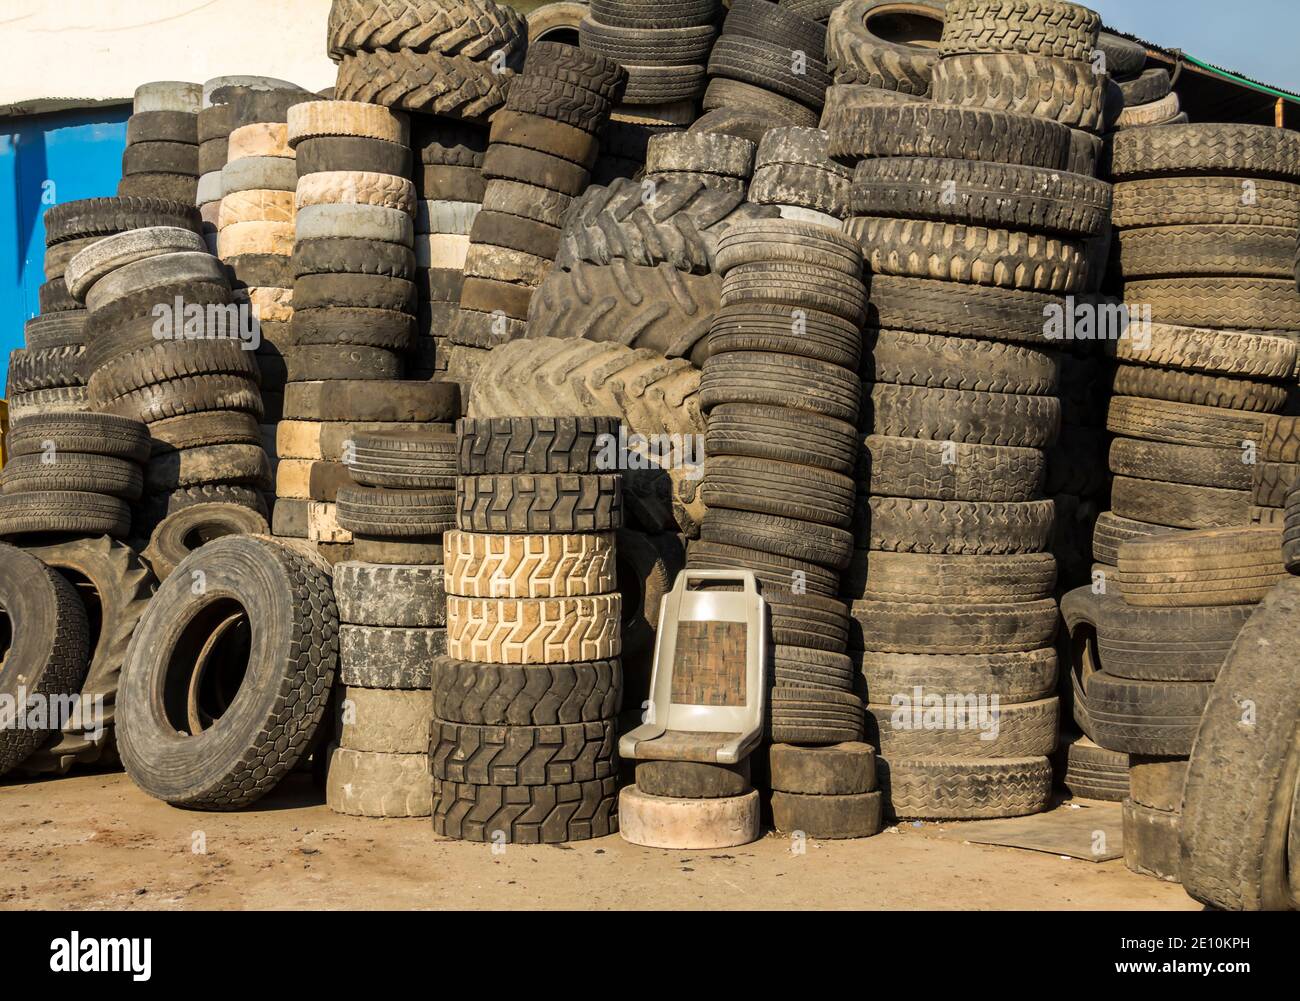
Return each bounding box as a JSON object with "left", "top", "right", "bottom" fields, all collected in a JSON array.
[{"left": 0, "top": 774, "right": 1199, "bottom": 910}]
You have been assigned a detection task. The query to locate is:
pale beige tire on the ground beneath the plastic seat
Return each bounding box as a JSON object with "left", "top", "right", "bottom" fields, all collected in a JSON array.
[{"left": 619, "top": 785, "right": 761, "bottom": 852}]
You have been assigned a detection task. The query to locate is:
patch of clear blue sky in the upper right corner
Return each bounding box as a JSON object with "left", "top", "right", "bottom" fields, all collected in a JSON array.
[{"left": 1079, "top": 0, "right": 1300, "bottom": 91}]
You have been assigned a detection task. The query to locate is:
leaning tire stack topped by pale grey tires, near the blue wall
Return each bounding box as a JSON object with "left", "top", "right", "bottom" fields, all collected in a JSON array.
[{"left": 68, "top": 226, "right": 270, "bottom": 553}]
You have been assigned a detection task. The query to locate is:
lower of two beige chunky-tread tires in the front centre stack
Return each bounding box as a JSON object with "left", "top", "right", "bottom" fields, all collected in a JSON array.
[{"left": 447, "top": 594, "right": 623, "bottom": 664}]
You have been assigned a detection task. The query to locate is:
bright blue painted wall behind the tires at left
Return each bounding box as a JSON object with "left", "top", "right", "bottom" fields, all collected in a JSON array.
[{"left": 0, "top": 104, "right": 131, "bottom": 395}]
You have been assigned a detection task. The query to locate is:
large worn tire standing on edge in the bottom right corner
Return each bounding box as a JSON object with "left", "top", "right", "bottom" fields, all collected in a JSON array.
[{"left": 1179, "top": 580, "right": 1300, "bottom": 910}]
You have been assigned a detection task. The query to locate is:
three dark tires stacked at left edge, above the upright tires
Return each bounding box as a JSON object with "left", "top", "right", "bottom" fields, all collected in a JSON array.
[{"left": 0, "top": 413, "right": 150, "bottom": 538}]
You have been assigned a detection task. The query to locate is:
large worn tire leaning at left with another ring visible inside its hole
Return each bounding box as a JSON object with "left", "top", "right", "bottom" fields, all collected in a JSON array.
[{"left": 116, "top": 534, "right": 339, "bottom": 811}]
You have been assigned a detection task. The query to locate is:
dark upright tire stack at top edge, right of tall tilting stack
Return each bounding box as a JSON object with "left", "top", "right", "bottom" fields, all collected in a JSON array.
[{"left": 579, "top": 0, "right": 722, "bottom": 125}]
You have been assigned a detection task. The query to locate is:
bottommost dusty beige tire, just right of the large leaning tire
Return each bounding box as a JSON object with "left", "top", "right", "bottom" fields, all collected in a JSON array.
[{"left": 325, "top": 746, "right": 433, "bottom": 818}]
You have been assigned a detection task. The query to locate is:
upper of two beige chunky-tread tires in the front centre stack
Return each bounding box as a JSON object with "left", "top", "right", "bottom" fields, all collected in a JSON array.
[{"left": 443, "top": 532, "right": 618, "bottom": 598}]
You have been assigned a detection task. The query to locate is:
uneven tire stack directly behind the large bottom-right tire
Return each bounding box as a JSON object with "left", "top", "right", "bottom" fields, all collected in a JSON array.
[{"left": 1061, "top": 525, "right": 1287, "bottom": 880}]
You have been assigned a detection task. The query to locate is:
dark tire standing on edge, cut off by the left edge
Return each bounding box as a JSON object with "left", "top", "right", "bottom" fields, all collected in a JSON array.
[{"left": 0, "top": 545, "right": 90, "bottom": 775}]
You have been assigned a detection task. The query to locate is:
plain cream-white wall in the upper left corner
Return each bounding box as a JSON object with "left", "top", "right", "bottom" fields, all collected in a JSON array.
[{"left": 0, "top": 0, "right": 337, "bottom": 114}]
